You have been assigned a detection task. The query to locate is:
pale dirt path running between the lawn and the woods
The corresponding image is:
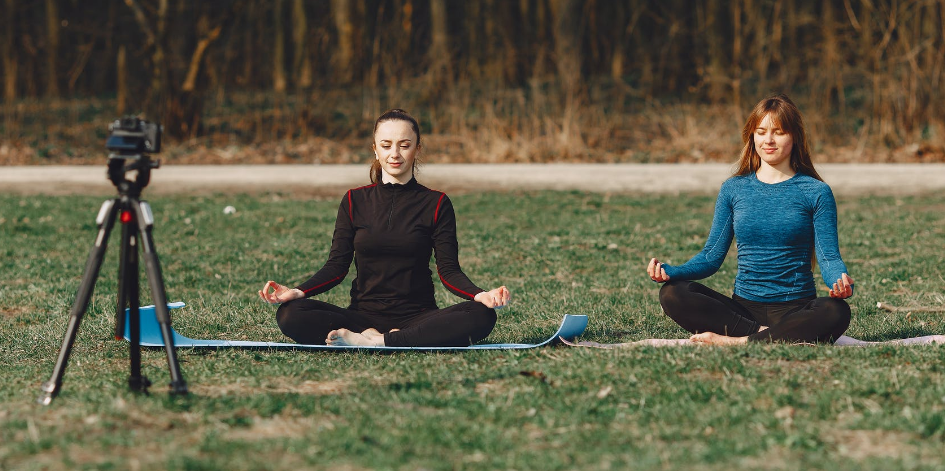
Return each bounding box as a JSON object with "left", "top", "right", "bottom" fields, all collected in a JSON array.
[{"left": 0, "top": 162, "right": 945, "bottom": 195}]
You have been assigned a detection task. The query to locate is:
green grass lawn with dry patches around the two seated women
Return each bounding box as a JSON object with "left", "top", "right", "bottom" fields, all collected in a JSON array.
[{"left": 0, "top": 192, "right": 945, "bottom": 470}]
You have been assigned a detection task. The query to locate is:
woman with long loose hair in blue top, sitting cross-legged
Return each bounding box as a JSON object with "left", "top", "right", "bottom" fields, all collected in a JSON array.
[{"left": 647, "top": 95, "right": 853, "bottom": 345}]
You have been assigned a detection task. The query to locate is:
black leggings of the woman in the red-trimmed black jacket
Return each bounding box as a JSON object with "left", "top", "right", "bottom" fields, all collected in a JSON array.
[{"left": 276, "top": 298, "right": 496, "bottom": 347}]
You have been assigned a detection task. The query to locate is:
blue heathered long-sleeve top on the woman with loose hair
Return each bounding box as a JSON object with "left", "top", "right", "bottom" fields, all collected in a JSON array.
[{"left": 663, "top": 173, "right": 847, "bottom": 302}]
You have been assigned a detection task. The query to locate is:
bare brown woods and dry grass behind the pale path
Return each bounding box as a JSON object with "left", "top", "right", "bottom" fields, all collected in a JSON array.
[{"left": 0, "top": 0, "right": 945, "bottom": 164}]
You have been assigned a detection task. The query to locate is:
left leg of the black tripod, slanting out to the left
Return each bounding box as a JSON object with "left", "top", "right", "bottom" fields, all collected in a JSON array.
[{"left": 37, "top": 199, "right": 119, "bottom": 405}]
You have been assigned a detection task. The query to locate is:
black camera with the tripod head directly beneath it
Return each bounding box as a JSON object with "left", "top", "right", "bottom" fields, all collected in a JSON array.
[{"left": 105, "top": 116, "right": 164, "bottom": 197}]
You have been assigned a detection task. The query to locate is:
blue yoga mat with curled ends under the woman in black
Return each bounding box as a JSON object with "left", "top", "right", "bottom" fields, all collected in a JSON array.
[{"left": 125, "top": 302, "right": 587, "bottom": 351}]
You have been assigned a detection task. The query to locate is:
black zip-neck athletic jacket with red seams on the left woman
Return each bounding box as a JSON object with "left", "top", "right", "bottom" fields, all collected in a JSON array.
[{"left": 298, "top": 179, "right": 484, "bottom": 315}]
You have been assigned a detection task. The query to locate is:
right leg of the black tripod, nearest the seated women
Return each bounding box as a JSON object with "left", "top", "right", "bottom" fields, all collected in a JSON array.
[{"left": 132, "top": 200, "right": 187, "bottom": 394}]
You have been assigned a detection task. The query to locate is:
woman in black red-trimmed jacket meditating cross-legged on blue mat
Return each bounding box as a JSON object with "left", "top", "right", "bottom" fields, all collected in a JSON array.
[{"left": 259, "top": 109, "right": 510, "bottom": 346}]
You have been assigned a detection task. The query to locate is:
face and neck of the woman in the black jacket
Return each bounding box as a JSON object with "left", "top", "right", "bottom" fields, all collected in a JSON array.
[{"left": 374, "top": 120, "right": 420, "bottom": 183}]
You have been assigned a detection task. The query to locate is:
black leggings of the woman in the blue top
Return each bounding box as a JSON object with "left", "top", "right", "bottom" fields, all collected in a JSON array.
[{"left": 660, "top": 281, "right": 850, "bottom": 343}]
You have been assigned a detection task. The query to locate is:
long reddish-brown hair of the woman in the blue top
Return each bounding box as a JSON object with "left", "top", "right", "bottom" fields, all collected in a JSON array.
[{"left": 735, "top": 93, "right": 824, "bottom": 181}]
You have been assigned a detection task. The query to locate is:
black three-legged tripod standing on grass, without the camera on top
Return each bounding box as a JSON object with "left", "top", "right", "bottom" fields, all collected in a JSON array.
[{"left": 37, "top": 154, "right": 187, "bottom": 405}]
